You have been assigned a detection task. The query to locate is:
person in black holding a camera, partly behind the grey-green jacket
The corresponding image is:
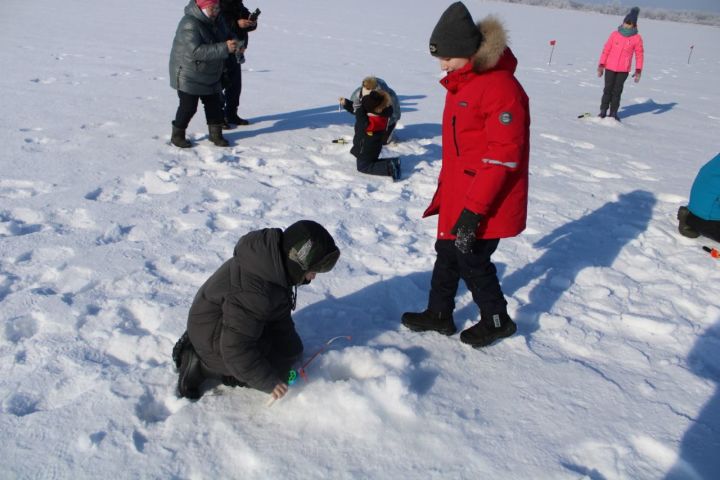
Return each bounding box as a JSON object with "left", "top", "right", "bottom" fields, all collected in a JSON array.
[{"left": 220, "top": 0, "right": 257, "bottom": 128}]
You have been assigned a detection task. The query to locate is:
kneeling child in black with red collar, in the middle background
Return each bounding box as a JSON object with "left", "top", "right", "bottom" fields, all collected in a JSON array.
[{"left": 340, "top": 90, "right": 400, "bottom": 180}]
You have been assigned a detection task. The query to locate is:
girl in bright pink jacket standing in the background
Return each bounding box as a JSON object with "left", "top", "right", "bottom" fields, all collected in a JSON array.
[{"left": 598, "top": 7, "right": 643, "bottom": 121}]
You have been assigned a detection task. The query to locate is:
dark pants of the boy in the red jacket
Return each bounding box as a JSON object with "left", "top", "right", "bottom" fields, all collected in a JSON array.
[{"left": 428, "top": 239, "right": 507, "bottom": 317}]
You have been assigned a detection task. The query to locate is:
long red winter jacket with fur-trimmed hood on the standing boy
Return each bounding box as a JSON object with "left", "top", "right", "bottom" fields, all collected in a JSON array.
[{"left": 423, "top": 22, "right": 530, "bottom": 240}]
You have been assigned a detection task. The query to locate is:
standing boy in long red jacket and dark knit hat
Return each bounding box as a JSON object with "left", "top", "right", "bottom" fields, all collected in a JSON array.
[{"left": 402, "top": 2, "right": 530, "bottom": 348}]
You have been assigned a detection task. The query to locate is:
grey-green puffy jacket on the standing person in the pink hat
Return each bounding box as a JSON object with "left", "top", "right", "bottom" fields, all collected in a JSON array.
[{"left": 170, "top": 0, "right": 230, "bottom": 95}]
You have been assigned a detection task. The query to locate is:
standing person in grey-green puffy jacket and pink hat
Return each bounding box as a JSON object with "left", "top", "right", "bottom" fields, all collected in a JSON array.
[{"left": 170, "top": 0, "right": 237, "bottom": 148}]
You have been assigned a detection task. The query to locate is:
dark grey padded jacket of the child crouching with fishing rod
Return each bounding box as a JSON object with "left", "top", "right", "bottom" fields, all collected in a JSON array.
[{"left": 188, "top": 228, "right": 299, "bottom": 392}]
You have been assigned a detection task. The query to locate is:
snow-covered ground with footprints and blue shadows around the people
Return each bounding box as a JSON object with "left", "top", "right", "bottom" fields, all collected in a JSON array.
[{"left": 0, "top": 0, "right": 720, "bottom": 480}]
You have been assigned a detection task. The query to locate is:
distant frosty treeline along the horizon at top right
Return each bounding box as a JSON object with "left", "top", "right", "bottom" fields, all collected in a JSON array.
[{"left": 492, "top": 0, "right": 720, "bottom": 26}]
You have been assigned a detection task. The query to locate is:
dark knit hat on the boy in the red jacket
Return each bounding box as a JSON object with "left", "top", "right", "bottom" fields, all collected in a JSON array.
[{"left": 430, "top": 2, "right": 483, "bottom": 58}]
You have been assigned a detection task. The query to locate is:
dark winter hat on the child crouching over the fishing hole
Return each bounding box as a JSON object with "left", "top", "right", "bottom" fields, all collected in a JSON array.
[{"left": 282, "top": 220, "right": 340, "bottom": 285}]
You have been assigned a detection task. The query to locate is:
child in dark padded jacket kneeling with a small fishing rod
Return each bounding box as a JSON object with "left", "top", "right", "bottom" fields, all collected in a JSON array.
[{"left": 173, "top": 220, "right": 340, "bottom": 399}]
